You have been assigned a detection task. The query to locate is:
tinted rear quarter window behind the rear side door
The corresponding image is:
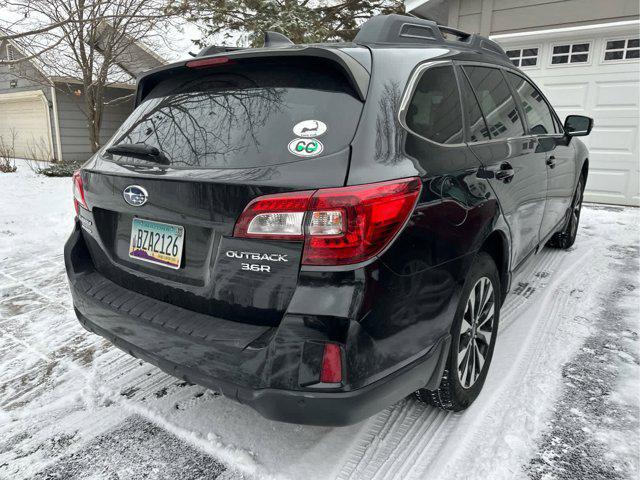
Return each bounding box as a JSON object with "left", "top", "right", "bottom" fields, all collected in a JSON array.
[{"left": 406, "top": 67, "right": 462, "bottom": 143}]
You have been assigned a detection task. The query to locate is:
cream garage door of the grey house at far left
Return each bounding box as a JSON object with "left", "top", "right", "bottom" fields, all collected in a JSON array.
[{"left": 0, "top": 90, "right": 52, "bottom": 160}]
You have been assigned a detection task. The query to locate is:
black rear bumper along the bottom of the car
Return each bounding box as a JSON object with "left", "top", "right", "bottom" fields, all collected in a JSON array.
[{"left": 65, "top": 226, "right": 450, "bottom": 425}]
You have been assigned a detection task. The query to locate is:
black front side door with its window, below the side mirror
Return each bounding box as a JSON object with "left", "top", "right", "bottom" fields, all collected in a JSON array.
[{"left": 505, "top": 71, "right": 576, "bottom": 239}]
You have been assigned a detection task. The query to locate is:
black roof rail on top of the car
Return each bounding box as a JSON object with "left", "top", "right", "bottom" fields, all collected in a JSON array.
[{"left": 353, "top": 14, "right": 509, "bottom": 60}]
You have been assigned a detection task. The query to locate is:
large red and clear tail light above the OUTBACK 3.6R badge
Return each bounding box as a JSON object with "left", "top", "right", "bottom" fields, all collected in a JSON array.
[{"left": 234, "top": 177, "right": 421, "bottom": 265}]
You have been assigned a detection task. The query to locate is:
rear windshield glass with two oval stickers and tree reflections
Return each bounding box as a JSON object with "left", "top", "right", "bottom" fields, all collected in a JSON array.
[{"left": 106, "top": 59, "right": 362, "bottom": 168}]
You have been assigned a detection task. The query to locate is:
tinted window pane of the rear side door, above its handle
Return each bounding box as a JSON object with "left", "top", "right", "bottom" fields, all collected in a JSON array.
[{"left": 464, "top": 66, "right": 524, "bottom": 138}]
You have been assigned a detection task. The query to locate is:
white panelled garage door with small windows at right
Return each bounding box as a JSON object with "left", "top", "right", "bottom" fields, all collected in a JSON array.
[{"left": 496, "top": 22, "right": 640, "bottom": 205}]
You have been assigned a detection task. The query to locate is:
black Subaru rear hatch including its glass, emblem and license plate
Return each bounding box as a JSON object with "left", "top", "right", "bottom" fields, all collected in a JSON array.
[{"left": 80, "top": 57, "right": 363, "bottom": 325}]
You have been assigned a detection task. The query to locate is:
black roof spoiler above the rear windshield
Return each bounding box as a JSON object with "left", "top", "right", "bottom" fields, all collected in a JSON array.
[{"left": 136, "top": 45, "right": 370, "bottom": 106}]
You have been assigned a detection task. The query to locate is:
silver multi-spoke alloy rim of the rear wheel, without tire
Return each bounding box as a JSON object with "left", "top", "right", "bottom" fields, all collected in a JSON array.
[{"left": 458, "top": 277, "right": 496, "bottom": 388}]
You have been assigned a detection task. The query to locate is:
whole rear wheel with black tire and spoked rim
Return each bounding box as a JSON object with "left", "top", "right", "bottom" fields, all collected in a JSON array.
[{"left": 416, "top": 252, "right": 502, "bottom": 412}]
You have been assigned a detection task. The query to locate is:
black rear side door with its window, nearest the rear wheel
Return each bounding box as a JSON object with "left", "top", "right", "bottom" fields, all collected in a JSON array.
[{"left": 462, "top": 65, "right": 547, "bottom": 266}]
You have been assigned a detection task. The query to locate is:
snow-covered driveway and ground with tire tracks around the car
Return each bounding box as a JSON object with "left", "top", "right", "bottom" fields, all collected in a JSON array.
[{"left": 0, "top": 164, "right": 640, "bottom": 480}]
